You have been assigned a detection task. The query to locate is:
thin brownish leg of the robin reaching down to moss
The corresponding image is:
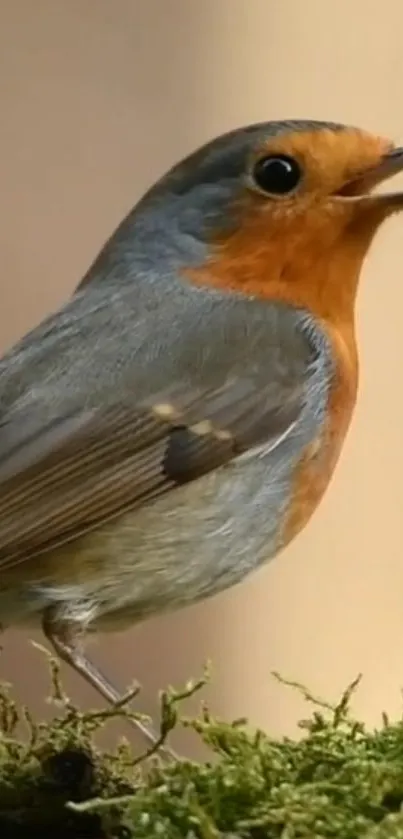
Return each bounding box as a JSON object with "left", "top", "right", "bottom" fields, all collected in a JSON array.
[{"left": 42, "top": 609, "right": 178, "bottom": 760}]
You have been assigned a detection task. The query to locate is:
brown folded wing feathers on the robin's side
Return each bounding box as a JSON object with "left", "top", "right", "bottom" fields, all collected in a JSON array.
[{"left": 0, "top": 375, "right": 302, "bottom": 571}]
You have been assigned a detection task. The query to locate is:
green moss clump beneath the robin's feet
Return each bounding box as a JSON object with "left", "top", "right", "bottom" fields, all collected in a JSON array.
[{"left": 0, "top": 661, "right": 403, "bottom": 839}]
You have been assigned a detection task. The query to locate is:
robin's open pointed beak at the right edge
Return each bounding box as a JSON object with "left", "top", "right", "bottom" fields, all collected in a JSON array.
[{"left": 334, "top": 146, "right": 403, "bottom": 209}]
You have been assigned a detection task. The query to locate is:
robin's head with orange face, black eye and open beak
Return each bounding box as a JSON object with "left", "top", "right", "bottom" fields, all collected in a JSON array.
[{"left": 137, "top": 121, "right": 403, "bottom": 324}]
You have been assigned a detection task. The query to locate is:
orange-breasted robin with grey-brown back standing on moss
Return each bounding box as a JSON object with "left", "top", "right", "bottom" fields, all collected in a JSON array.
[{"left": 0, "top": 119, "right": 403, "bottom": 756}]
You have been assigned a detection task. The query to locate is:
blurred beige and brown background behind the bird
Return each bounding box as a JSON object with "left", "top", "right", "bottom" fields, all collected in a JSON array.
[{"left": 0, "top": 0, "right": 403, "bottom": 756}]
